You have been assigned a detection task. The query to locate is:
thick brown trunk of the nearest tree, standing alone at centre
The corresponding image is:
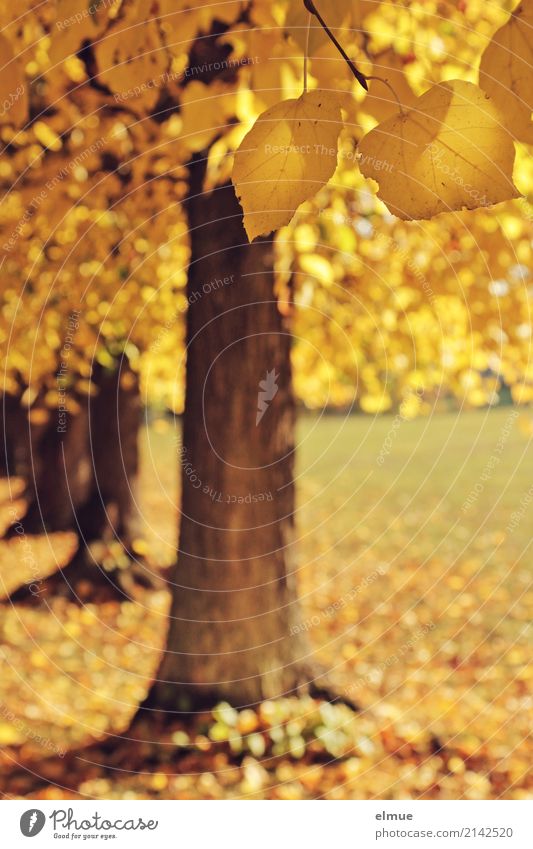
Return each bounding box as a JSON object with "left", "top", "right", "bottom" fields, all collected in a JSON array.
[{"left": 152, "top": 160, "right": 303, "bottom": 709}]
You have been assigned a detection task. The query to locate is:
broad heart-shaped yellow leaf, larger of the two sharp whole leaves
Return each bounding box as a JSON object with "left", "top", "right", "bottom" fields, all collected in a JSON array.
[{"left": 359, "top": 80, "right": 518, "bottom": 219}]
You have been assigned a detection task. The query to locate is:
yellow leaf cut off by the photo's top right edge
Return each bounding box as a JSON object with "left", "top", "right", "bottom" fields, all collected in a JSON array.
[{"left": 479, "top": 0, "right": 533, "bottom": 143}]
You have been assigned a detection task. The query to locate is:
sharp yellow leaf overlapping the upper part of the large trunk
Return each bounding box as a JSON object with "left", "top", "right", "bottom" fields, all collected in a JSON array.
[{"left": 233, "top": 91, "right": 342, "bottom": 241}]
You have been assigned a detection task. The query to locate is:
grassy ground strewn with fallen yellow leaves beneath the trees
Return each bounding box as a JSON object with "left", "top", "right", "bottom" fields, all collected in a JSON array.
[{"left": 0, "top": 408, "right": 533, "bottom": 799}]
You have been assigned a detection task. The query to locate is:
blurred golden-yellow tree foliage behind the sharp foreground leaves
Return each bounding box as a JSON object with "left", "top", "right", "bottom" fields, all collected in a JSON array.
[{"left": 0, "top": 0, "right": 533, "bottom": 415}]
